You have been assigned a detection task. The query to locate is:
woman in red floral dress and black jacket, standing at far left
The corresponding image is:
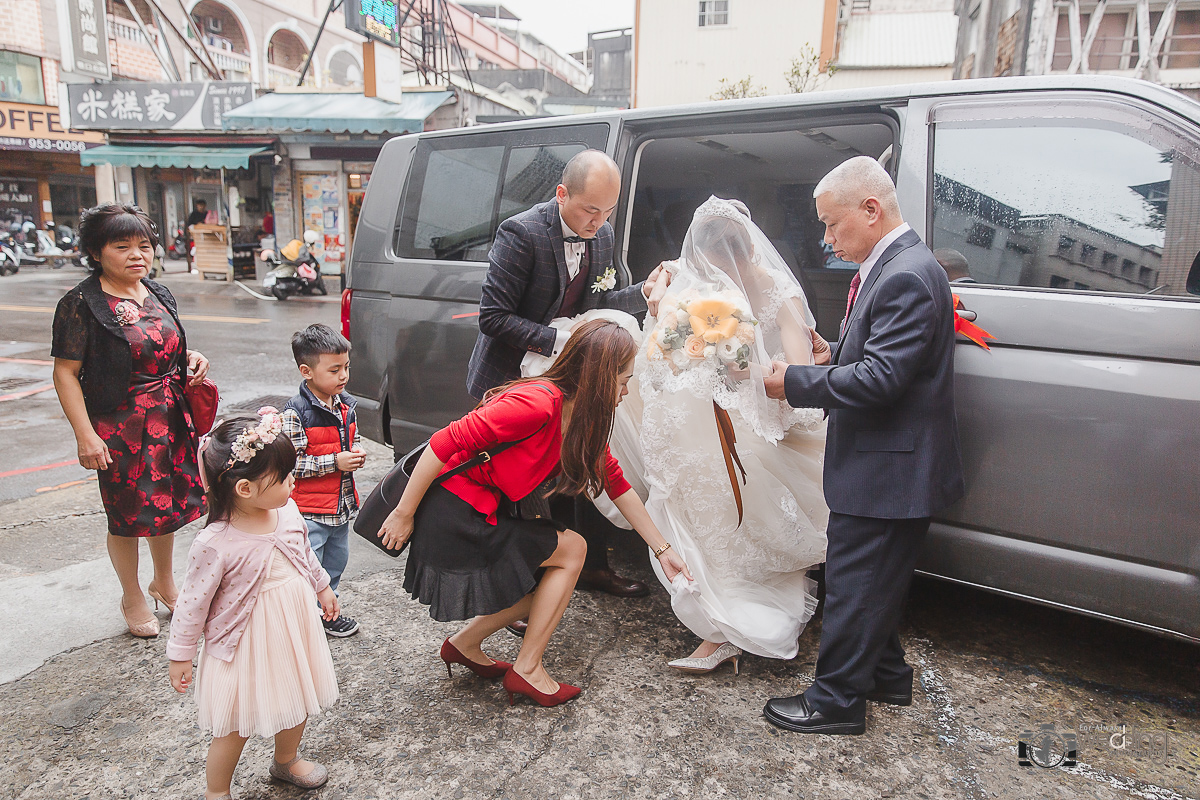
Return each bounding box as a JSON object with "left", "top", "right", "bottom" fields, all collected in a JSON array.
[{"left": 50, "top": 203, "right": 209, "bottom": 638}]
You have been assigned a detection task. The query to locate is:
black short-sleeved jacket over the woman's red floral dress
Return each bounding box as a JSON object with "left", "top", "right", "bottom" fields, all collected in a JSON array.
[{"left": 50, "top": 275, "right": 187, "bottom": 415}]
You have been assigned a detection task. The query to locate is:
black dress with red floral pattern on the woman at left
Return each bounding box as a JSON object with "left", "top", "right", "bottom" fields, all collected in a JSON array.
[{"left": 91, "top": 293, "right": 204, "bottom": 536}]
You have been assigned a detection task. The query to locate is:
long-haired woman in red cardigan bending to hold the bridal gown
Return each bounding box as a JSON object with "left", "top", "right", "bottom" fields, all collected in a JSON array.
[{"left": 379, "top": 319, "right": 691, "bottom": 706}]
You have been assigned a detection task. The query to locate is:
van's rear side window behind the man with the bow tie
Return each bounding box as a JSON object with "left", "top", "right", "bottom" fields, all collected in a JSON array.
[{"left": 395, "top": 124, "right": 608, "bottom": 261}]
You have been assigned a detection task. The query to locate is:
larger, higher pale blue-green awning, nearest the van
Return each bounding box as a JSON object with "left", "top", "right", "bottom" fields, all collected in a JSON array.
[{"left": 221, "top": 91, "right": 454, "bottom": 133}]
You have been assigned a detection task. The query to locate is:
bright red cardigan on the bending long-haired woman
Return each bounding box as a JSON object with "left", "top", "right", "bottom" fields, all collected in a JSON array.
[{"left": 430, "top": 381, "right": 630, "bottom": 525}]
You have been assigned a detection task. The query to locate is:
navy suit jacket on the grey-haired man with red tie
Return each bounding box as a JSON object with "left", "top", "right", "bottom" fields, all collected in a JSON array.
[{"left": 785, "top": 230, "right": 965, "bottom": 519}]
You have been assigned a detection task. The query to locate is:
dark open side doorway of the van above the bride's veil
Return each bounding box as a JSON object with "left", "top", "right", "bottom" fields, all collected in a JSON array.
[{"left": 625, "top": 118, "right": 895, "bottom": 338}]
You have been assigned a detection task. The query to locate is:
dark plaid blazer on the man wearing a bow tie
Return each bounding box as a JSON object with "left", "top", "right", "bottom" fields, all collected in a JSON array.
[{"left": 467, "top": 199, "right": 646, "bottom": 399}]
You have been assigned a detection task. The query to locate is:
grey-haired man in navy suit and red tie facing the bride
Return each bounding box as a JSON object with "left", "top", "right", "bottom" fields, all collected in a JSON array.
[{"left": 763, "top": 156, "right": 965, "bottom": 734}]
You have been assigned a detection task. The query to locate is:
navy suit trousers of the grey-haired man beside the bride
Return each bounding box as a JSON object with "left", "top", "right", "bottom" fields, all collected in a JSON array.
[{"left": 804, "top": 512, "right": 930, "bottom": 714}]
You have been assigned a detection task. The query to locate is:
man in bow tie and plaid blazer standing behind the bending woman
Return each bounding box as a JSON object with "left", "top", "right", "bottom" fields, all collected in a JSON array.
[{"left": 467, "top": 150, "right": 670, "bottom": 597}]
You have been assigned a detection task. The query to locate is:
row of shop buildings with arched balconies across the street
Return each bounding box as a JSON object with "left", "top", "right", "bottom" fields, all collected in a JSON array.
[{"left": 9, "top": 0, "right": 589, "bottom": 280}]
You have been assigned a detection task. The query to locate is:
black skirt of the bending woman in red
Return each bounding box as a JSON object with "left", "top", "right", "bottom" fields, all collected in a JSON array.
[{"left": 404, "top": 486, "right": 564, "bottom": 622}]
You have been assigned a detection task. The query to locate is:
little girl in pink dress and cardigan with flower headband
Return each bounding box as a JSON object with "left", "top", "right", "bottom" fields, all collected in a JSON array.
[{"left": 167, "top": 408, "right": 340, "bottom": 800}]
